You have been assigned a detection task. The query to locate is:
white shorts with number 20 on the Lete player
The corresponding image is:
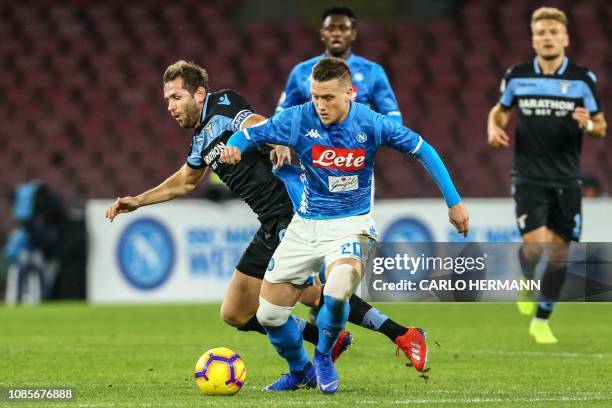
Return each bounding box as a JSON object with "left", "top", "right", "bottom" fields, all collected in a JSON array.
[{"left": 264, "top": 214, "right": 377, "bottom": 285}]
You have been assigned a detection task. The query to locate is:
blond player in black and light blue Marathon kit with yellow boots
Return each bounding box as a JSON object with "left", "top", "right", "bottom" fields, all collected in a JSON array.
[{"left": 487, "top": 7, "right": 606, "bottom": 343}]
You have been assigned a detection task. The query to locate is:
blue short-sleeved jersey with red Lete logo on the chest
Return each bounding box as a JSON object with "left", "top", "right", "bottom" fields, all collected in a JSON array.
[{"left": 245, "top": 102, "right": 422, "bottom": 219}]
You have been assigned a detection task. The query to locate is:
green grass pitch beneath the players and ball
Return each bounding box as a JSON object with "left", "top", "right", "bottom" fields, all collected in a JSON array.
[{"left": 0, "top": 303, "right": 612, "bottom": 407}]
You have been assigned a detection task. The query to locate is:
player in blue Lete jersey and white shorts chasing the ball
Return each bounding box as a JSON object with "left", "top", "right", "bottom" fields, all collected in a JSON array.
[{"left": 221, "top": 58, "right": 468, "bottom": 394}]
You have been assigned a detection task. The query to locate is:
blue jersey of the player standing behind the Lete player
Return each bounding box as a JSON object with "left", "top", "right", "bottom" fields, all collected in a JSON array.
[{"left": 276, "top": 54, "right": 402, "bottom": 123}]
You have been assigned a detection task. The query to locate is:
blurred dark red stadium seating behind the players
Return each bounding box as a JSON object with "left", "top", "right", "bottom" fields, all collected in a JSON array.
[{"left": 0, "top": 0, "right": 612, "bottom": 296}]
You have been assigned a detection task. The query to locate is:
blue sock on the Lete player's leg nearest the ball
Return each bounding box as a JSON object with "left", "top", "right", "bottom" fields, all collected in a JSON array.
[{"left": 264, "top": 316, "right": 310, "bottom": 372}]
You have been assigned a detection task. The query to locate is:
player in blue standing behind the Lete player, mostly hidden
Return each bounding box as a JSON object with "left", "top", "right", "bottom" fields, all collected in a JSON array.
[{"left": 276, "top": 6, "right": 402, "bottom": 123}]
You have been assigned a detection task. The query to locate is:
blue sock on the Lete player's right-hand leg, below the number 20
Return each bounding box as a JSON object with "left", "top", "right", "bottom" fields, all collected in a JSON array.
[{"left": 317, "top": 296, "right": 350, "bottom": 354}]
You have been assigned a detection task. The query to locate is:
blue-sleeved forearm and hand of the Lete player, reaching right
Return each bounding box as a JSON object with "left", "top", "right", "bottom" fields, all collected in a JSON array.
[{"left": 414, "top": 140, "right": 470, "bottom": 237}]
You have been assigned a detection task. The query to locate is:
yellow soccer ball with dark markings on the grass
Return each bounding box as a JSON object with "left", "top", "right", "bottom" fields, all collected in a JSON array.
[{"left": 194, "top": 347, "right": 246, "bottom": 395}]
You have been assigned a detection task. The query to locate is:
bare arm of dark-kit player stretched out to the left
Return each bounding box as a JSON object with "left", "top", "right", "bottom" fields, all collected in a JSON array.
[{"left": 106, "top": 164, "right": 206, "bottom": 221}]
